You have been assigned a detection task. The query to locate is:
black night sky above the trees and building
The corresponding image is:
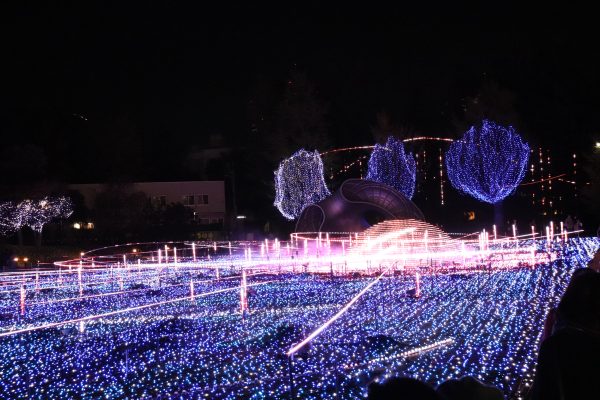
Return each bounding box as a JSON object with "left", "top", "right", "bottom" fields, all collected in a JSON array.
[{"left": 0, "top": 1, "right": 600, "bottom": 180}]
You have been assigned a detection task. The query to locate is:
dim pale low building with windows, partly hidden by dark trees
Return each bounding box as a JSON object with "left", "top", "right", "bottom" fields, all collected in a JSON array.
[{"left": 69, "top": 181, "right": 227, "bottom": 226}]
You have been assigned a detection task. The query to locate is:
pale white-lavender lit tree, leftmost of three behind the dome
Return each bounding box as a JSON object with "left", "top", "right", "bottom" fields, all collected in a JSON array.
[{"left": 274, "top": 149, "right": 330, "bottom": 220}]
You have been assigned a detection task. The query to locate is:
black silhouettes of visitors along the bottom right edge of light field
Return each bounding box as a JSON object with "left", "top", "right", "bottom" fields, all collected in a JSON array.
[{"left": 368, "top": 251, "right": 600, "bottom": 400}]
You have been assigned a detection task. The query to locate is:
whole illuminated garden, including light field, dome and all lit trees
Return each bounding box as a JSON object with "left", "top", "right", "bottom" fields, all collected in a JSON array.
[{"left": 0, "top": 121, "right": 600, "bottom": 399}]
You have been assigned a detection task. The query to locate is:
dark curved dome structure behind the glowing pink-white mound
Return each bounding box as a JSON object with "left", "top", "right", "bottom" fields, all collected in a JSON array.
[{"left": 296, "top": 179, "right": 425, "bottom": 232}]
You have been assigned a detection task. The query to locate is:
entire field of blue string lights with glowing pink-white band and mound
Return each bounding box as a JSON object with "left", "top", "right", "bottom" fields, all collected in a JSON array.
[{"left": 0, "top": 228, "right": 600, "bottom": 399}]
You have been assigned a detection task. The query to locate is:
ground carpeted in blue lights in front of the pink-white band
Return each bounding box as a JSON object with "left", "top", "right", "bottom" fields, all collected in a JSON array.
[{"left": 0, "top": 239, "right": 599, "bottom": 399}]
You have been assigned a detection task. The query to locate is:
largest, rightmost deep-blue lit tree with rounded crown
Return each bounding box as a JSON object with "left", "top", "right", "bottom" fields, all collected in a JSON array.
[{"left": 446, "top": 120, "right": 529, "bottom": 204}]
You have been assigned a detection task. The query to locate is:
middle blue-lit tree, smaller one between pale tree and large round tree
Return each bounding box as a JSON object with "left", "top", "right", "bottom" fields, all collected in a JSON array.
[{"left": 367, "top": 136, "right": 416, "bottom": 199}]
